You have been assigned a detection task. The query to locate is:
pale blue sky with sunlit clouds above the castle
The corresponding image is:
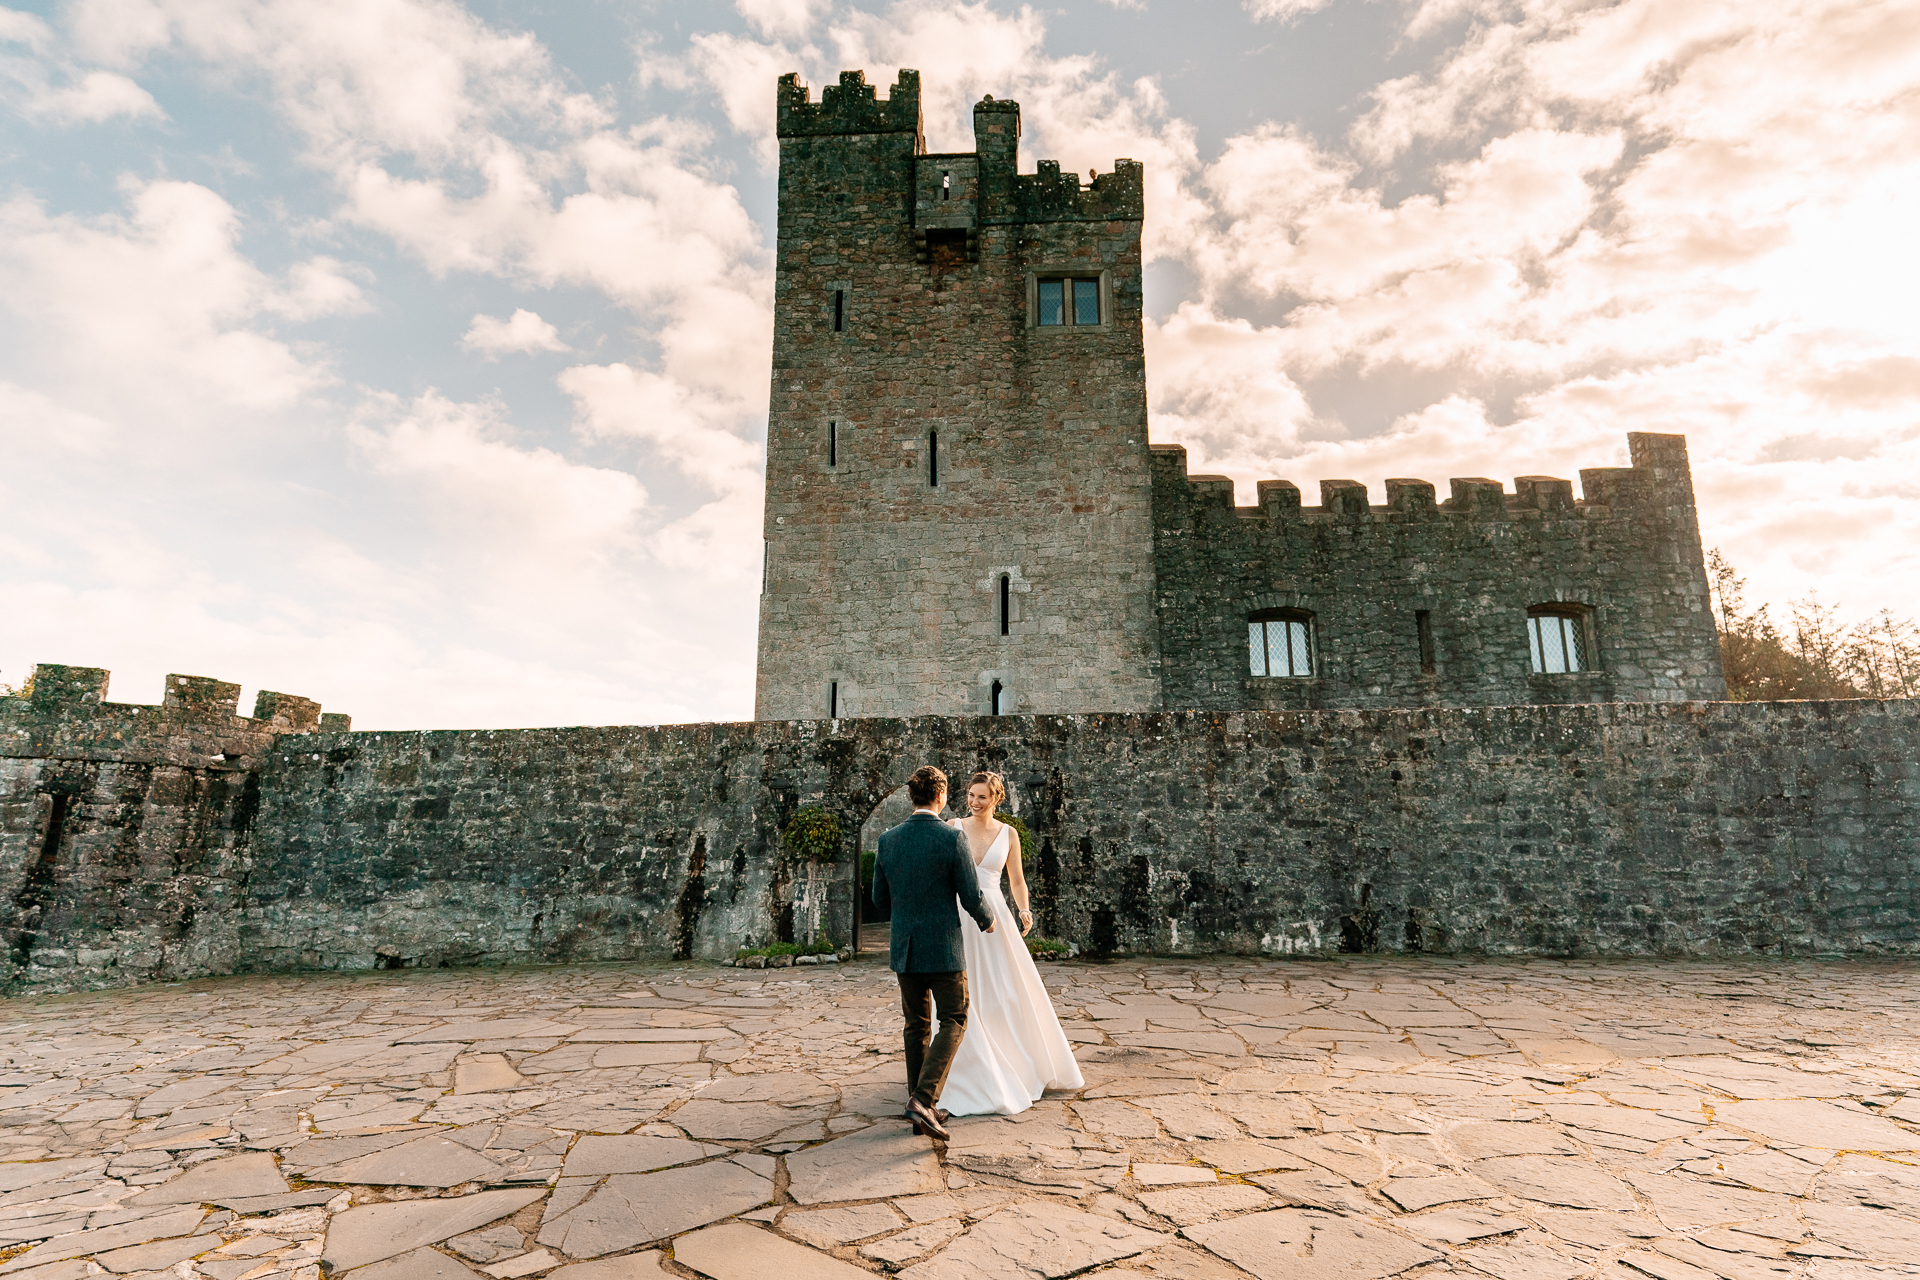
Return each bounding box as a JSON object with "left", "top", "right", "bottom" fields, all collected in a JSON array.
[{"left": 0, "top": 0, "right": 1920, "bottom": 727}]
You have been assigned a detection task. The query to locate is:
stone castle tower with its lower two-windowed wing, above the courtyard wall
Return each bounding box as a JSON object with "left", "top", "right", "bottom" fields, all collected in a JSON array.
[{"left": 755, "top": 71, "right": 1726, "bottom": 720}]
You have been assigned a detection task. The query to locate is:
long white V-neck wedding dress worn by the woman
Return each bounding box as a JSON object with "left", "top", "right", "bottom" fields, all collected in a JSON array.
[{"left": 937, "top": 821, "right": 1085, "bottom": 1115}]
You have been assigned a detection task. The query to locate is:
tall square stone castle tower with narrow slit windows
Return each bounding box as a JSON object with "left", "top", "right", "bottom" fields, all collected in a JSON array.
[{"left": 756, "top": 71, "right": 1162, "bottom": 720}]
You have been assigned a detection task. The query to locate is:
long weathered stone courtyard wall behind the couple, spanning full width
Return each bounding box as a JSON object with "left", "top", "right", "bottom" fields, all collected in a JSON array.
[{"left": 0, "top": 668, "right": 1920, "bottom": 990}]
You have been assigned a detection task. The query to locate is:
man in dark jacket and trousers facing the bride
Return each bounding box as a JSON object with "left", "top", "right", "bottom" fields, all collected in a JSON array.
[{"left": 874, "top": 764, "right": 993, "bottom": 1140}]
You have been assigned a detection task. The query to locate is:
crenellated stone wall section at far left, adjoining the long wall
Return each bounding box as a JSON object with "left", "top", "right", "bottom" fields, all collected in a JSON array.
[{"left": 0, "top": 664, "right": 351, "bottom": 990}]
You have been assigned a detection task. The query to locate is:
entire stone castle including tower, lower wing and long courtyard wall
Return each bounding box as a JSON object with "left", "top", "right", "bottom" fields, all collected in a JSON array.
[{"left": 0, "top": 71, "right": 1920, "bottom": 990}]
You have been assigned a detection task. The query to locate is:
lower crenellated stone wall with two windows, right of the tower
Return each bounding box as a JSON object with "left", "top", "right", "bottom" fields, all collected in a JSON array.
[{"left": 1154, "top": 432, "right": 1726, "bottom": 710}]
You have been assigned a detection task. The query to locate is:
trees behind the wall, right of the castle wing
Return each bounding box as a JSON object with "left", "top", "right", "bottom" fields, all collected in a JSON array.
[{"left": 1707, "top": 547, "right": 1920, "bottom": 702}]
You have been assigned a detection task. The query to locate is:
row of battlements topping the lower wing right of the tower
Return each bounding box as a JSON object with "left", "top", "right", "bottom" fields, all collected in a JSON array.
[{"left": 1152, "top": 432, "right": 1693, "bottom": 522}]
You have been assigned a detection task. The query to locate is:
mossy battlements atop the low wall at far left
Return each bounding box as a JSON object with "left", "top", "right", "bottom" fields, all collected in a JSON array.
[{"left": 0, "top": 662, "right": 353, "bottom": 770}]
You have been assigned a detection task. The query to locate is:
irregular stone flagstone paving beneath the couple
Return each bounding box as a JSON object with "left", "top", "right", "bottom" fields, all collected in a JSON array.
[{"left": 0, "top": 958, "right": 1920, "bottom": 1280}]
